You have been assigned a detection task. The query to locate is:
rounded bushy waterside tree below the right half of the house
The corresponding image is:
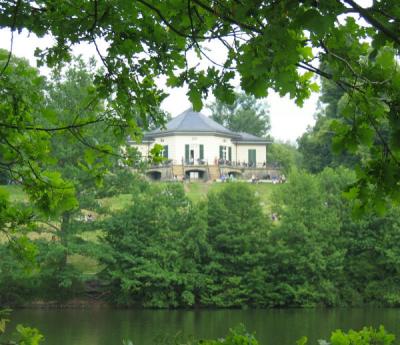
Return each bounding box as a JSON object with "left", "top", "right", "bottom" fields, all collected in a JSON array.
[{"left": 201, "top": 183, "right": 268, "bottom": 307}]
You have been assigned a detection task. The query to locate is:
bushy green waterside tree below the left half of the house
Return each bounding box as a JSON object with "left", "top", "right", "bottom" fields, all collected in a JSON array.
[{"left": 101, "top": 184, "right": 193, "bottom": 308}]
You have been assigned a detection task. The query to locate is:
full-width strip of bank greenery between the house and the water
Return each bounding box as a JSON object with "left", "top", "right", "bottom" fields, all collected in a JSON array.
[{"left": 0, "top": 168, "right": 400, "bottom": 308}]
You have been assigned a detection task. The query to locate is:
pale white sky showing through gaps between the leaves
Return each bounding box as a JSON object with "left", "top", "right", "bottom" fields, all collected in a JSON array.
[{"left": 0, "top": 29, "right": 318, "bottom": 143}]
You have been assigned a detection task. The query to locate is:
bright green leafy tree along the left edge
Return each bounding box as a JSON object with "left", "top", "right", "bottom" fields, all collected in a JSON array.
[{"left": 0, "top": 50, "right": 76, "bottom": 274}]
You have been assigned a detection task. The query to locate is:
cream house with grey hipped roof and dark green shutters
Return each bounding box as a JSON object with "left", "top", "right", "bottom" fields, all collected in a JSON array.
[{"left": 129, "top": 109, "right": 279, "bottom": 180}]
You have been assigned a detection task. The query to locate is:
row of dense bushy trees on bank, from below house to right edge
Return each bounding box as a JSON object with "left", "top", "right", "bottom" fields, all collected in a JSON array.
[{"left": 101, "top": 169, "right": 400, "bottom": 308}]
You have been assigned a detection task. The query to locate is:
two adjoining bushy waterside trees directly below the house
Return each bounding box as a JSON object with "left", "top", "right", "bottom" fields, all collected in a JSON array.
[{"left": 101, "top": 184, "right": 267, "bottom": 307}]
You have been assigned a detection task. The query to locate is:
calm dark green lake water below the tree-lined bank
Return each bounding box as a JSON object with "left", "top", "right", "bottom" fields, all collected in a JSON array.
[{"left": 5, "top": 308, "right": 400, "bottom": 345}]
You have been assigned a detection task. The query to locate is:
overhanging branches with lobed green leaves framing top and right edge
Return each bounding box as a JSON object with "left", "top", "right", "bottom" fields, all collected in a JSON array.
[{"left": 0, "top": 0, "right": 400, "bottom": 210}]
